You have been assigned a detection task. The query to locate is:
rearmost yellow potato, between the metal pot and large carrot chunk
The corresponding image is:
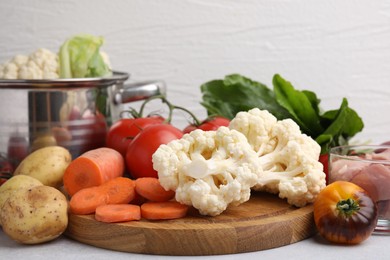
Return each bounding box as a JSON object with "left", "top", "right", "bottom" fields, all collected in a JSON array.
[{"left": 14, "top": 146, "right": 72, "bottom": 188}]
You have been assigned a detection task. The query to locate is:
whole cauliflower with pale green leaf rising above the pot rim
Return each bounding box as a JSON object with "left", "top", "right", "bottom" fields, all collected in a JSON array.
[{"left": 0, "top": 34, "right": 112, "bottom": 80}]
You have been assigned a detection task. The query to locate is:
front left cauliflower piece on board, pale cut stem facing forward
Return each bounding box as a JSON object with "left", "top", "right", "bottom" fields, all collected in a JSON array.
[{"left": 152, "top": 127, "right": 261, "bottom": 216}]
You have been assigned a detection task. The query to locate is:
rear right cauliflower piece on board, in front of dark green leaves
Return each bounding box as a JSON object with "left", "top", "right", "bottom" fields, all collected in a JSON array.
[{"left": 229, "top": 108, "right": 326, "bottom": 207}]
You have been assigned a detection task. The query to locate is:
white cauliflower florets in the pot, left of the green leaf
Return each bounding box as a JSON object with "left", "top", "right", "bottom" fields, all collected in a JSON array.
[{"left": 0, "top": 48, "right": 59, "bottom": 79}]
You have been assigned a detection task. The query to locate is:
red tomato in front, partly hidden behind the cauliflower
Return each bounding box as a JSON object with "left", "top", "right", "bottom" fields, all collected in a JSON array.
[{"left": 126, "top": 124, "right": 183, "bottom": 179}]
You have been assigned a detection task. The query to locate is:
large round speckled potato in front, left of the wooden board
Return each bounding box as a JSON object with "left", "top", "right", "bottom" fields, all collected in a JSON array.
[{"left": 0, "top": 186, "right": 68, "bottom": 244}]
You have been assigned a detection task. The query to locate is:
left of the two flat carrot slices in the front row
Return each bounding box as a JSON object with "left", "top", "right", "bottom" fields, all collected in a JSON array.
[{"left": 95, "top": 204, "right": 141, "bottom": 223}]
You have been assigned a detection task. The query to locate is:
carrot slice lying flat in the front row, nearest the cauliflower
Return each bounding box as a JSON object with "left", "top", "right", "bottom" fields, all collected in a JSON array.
[{"left": 141, "top": 201, "right": 189, "bottom": 220}]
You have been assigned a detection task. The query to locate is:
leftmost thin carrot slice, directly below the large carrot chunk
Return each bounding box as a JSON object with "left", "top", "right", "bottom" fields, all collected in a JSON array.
[{"left": 69, "top": 187, "right": 108, "bottom": 215}]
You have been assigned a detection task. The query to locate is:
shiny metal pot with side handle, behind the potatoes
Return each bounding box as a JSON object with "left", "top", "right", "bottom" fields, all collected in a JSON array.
[{"left": 0, "top": 72, "right": 166, "bottom": 165}]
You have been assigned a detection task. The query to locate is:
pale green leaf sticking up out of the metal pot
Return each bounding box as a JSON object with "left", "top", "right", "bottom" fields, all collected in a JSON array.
[{"left": 59, "top": 34, "right": 112, "bottom": 78}]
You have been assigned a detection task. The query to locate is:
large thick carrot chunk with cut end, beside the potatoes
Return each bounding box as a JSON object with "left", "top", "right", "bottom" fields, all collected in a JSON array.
[{"left": 63, "top": 147, "right": 125, "bottom": 196}]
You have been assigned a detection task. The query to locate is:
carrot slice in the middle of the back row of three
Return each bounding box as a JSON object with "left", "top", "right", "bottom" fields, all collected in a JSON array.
[{"left": 100, "top": 177, "right": 135, "bottom": 204}]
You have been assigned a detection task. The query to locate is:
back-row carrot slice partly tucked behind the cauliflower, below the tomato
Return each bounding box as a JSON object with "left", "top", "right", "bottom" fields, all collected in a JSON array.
[{"left": 135, "top": 177, "right": 175, "bottom": 202}]
